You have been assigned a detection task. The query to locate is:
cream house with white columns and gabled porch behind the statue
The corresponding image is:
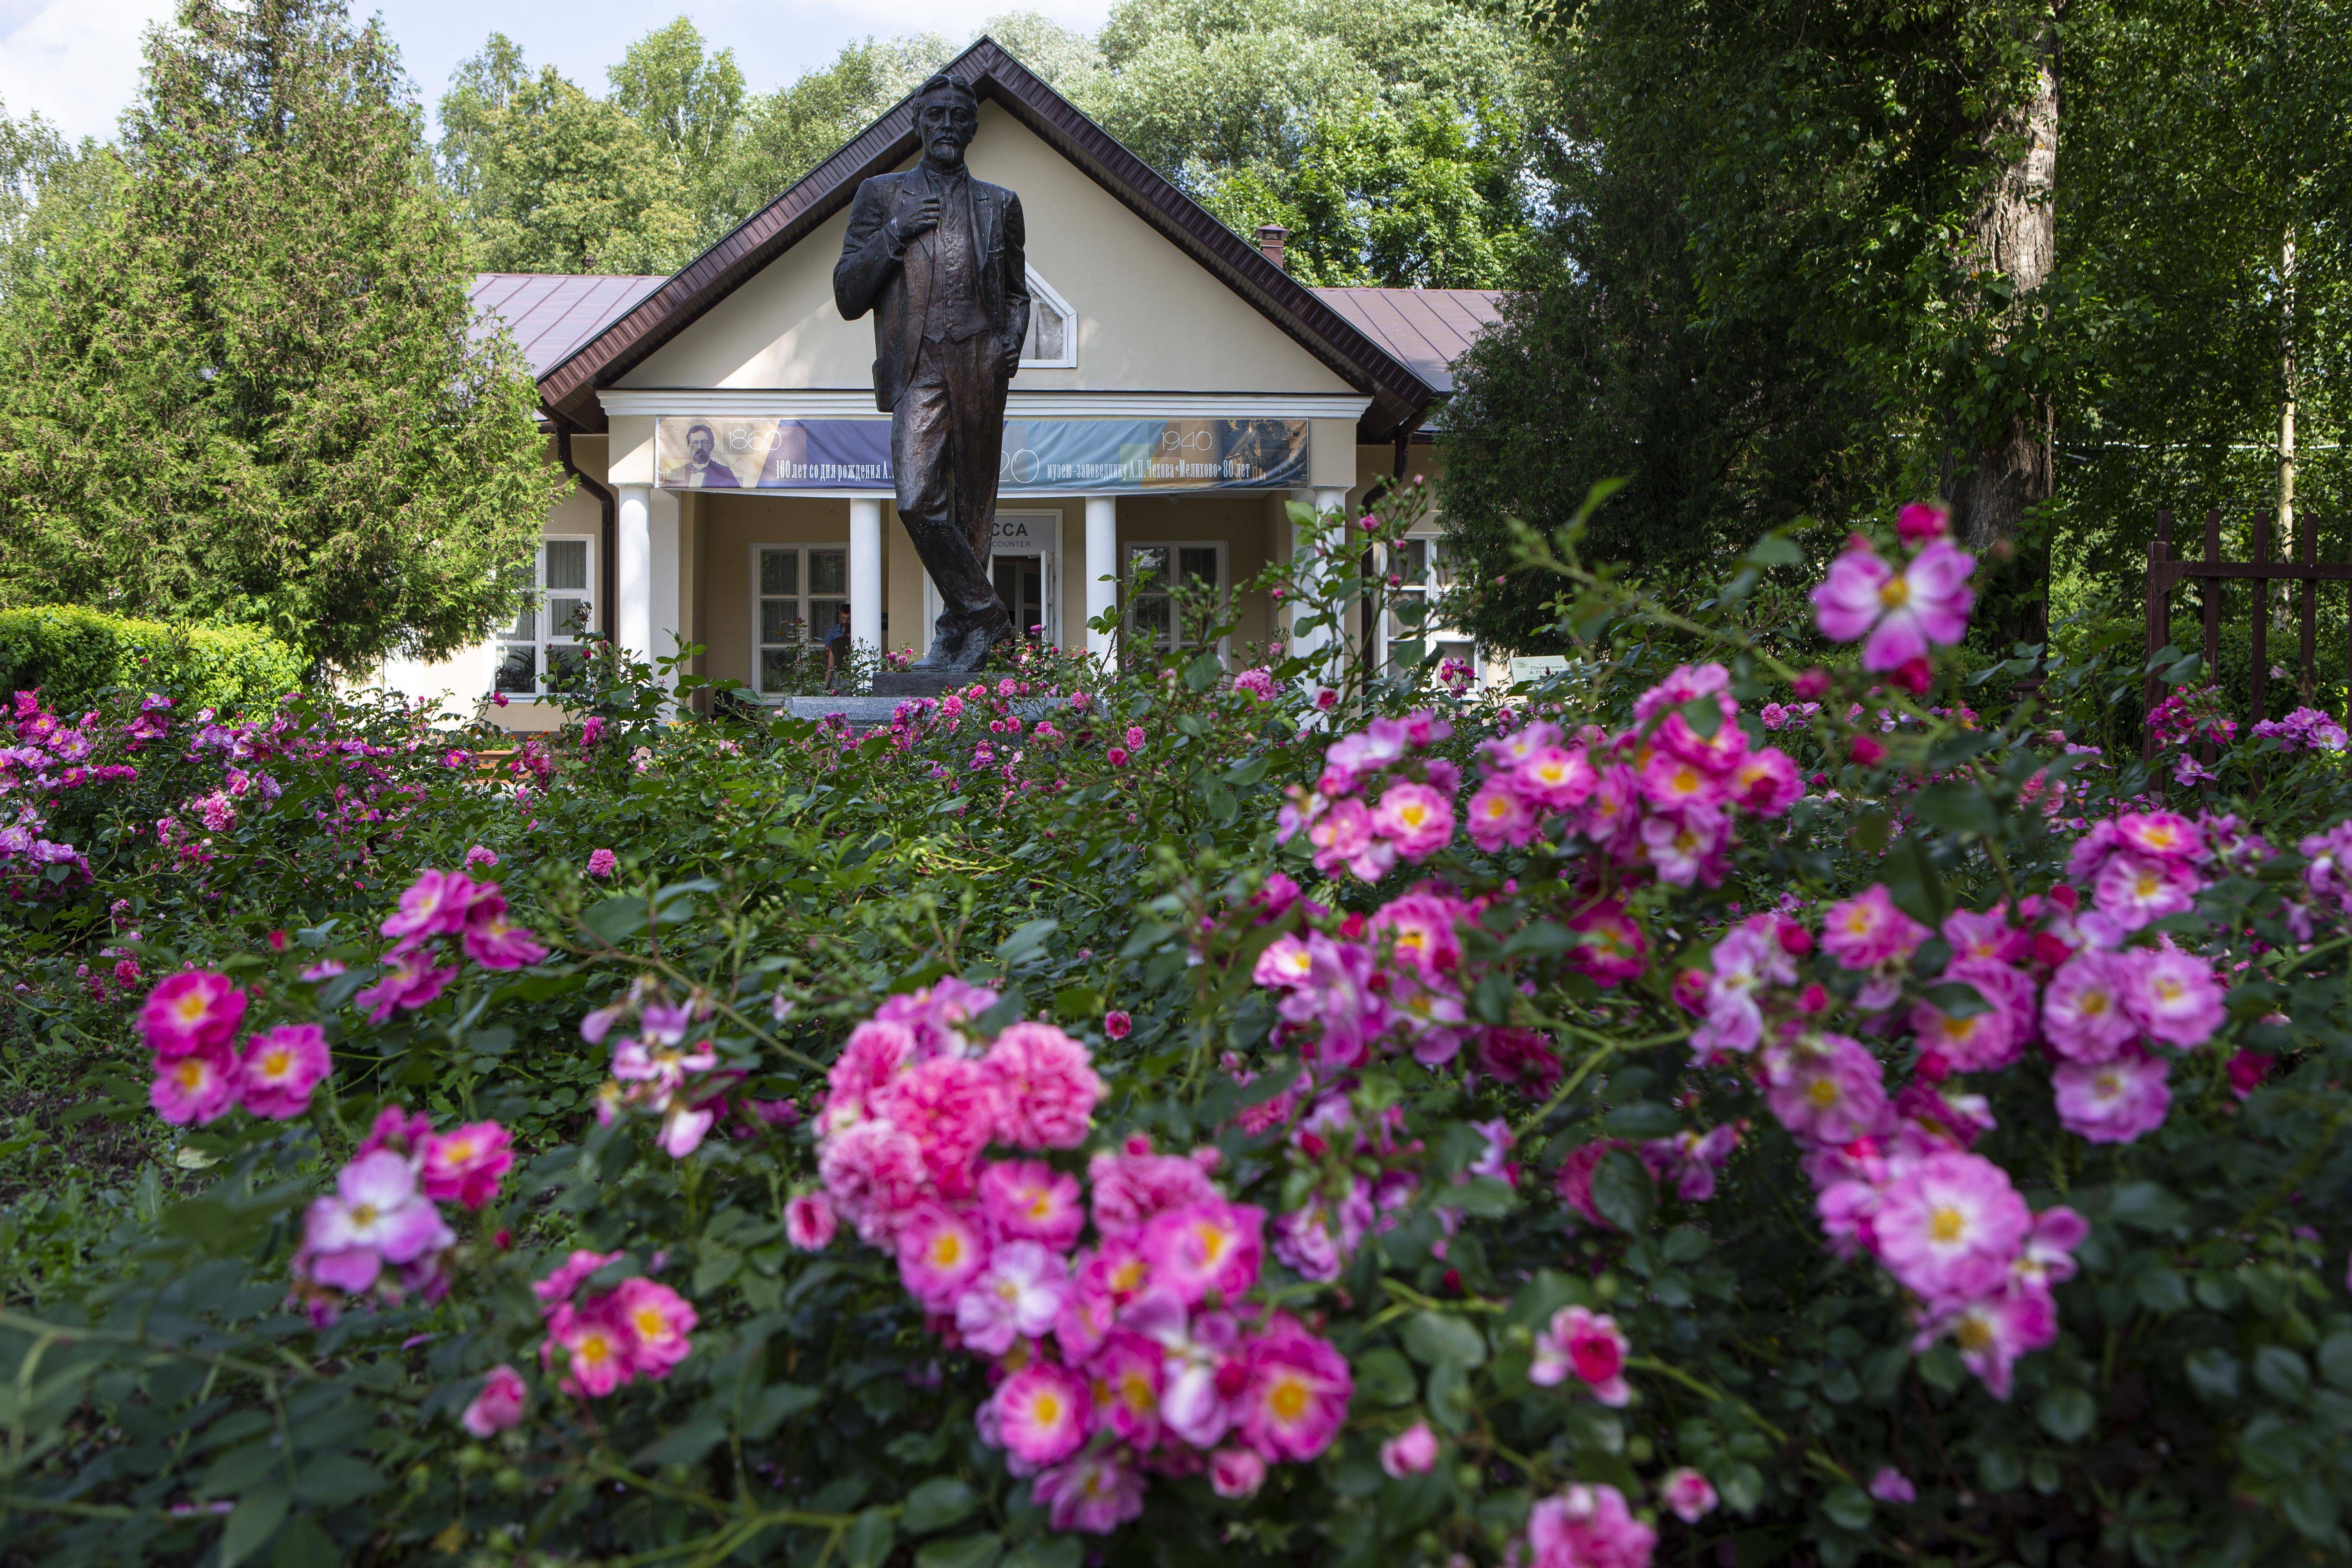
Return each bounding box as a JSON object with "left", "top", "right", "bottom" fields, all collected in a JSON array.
[{"left": 386, "top": 40, "right": 1496, "bottom": 729}]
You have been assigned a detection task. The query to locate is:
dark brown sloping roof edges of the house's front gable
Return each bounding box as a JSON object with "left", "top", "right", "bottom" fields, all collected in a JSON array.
[{"left": 539, "top": 38, "right": 1440, "bottom": 442}]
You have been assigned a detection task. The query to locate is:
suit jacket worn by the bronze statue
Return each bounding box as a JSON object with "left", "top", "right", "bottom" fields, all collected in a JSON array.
[{"left": 832, "top": 164, "right": 1030, "bottom": 414}]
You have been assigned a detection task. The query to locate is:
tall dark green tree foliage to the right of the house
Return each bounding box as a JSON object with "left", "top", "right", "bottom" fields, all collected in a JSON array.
[{"left": 1444, "top": 0, "right": 2352, "bottom": 647}]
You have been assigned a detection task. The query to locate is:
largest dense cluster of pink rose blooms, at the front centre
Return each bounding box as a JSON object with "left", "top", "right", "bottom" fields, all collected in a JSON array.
[{"left": 813, "top": 980, "right": 1355, "bottom": 1533}]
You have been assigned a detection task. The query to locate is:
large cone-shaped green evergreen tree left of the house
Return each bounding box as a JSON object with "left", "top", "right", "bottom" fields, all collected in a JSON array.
[{"left": 0, "top": 0, "right": 560, "bottom": 668}]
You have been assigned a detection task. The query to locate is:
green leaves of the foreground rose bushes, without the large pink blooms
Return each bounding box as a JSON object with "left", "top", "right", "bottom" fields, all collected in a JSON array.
[{"left": 0, "top": 505, "right": 2352, "bottom": 1568}]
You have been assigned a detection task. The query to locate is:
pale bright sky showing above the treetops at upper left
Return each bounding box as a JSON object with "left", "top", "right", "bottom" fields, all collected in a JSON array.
[{"left": 0, "top": 0, "right": 1110, "bottom": 136}]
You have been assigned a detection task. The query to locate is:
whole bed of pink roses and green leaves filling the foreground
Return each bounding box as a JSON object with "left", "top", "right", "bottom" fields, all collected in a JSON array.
[{"left": 0, "top": 508, "right": 2352, "bottom": 1568}]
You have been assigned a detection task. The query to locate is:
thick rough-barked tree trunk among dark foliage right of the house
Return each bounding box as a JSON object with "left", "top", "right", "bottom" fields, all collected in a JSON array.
[{"left": 1943, "top": 2, "right": 2058, "bottom": 642}]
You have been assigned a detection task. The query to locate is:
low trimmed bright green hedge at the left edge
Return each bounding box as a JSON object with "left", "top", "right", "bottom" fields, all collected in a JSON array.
[{"left": 0, "top": 604, "right": 303, "bottom": 712}]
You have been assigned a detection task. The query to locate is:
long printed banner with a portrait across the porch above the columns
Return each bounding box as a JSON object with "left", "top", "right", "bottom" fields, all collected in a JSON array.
[{"left": 654, "top": 414, "right": 1308, "bottom": 496}]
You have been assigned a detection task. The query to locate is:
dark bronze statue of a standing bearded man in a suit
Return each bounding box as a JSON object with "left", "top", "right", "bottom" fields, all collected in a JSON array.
[{"left": 832, "top": 75, "right": 1030, "bottom": 670}]
